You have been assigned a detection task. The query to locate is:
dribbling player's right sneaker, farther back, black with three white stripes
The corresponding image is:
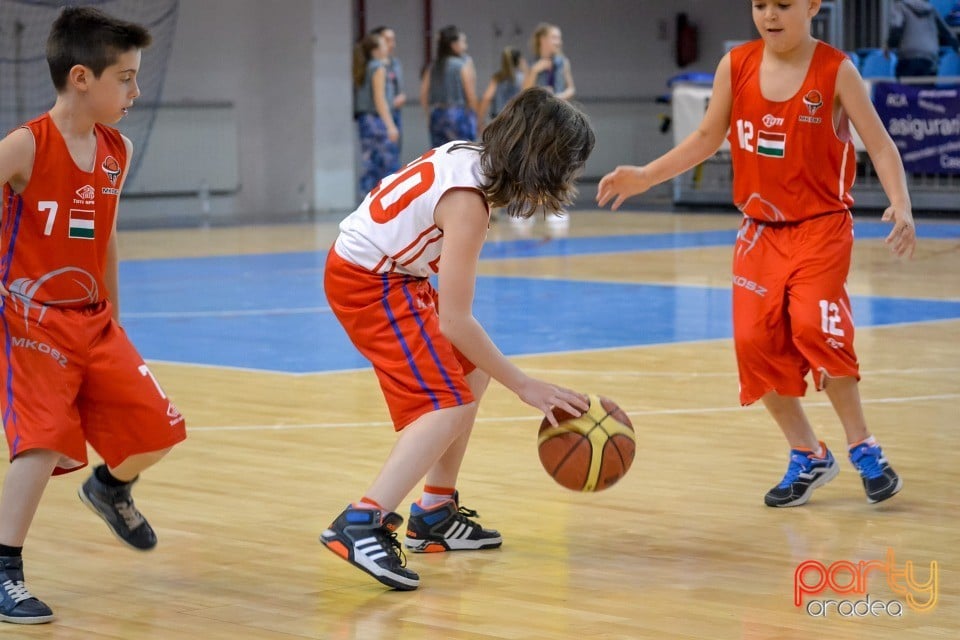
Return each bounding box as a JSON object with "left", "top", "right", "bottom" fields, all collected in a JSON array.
[{"left": 403, "top": 495, "right": 503, "bottom": 553}]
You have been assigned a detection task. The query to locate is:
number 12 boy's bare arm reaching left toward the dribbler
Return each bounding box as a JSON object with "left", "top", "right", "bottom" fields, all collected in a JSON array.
[{"left": 597, "top": 54, "right": 733, "bottom": 211}]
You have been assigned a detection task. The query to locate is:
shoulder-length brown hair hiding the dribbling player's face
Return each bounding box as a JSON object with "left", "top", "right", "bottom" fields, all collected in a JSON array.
[{"left": 464, "top": 87, "right": 596, "bottom": 218}]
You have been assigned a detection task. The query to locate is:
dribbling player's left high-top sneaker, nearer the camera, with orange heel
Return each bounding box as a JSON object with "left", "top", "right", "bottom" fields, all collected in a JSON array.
[{"left": 320, "top": 505, "right": 420, "bottom": 591}]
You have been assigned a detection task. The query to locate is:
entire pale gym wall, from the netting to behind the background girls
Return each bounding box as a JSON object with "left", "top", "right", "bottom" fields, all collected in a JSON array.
[{"left": 121, "top": 0, "right": 754, "bottom": 226}]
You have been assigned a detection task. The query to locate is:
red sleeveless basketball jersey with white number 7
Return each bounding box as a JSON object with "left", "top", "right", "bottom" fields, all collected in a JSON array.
[{"left": 0, "top": 114, "right": 127, "bottom": 307}]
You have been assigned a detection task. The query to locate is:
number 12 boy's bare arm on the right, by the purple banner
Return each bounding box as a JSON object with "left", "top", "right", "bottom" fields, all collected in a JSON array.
[{"left": 836, "top": 60, "right": 917, "bottom": 257}]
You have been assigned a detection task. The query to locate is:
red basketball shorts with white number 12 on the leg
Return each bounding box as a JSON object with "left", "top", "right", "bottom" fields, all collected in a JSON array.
[{"left": 733, "top": 212, "right": 859, "bottom": 405}]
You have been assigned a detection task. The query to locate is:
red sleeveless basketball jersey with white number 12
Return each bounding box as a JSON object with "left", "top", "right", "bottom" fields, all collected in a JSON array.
[{"left": 729, "top": 40, "right": 856, "bottom": 222}]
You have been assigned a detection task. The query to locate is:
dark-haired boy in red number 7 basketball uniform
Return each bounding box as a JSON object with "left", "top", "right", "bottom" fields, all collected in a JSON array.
[{"left": 0, "top": 7, "right": 186, "bottom": 624}]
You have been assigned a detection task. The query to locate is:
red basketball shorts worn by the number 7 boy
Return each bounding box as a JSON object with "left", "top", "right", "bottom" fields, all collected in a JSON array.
[{"left": 0, "top": 297, "right": 186, "bottom": 474}]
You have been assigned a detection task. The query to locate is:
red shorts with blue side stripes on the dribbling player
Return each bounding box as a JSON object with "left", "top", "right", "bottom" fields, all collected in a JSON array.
[{"left": 323, "top": 248, "right": 476, "bottom": 431}]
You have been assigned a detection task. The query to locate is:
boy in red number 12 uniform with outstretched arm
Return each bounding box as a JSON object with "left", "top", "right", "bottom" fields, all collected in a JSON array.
[{"left": 597, "top": 0, "right": 916, "bottom": 507}]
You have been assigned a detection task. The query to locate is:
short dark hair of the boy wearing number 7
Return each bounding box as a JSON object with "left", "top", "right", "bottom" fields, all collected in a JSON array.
[{"left": 47, "top": 7, "right": 152, "bottom": 91}]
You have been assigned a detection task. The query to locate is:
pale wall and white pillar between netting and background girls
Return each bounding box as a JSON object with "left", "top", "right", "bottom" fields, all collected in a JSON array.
[{"left": 121, "top": 0, "right": 355, "bottom": 226}]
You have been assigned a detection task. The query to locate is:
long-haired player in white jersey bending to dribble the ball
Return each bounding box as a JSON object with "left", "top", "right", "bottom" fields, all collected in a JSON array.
[{"left": 320, "top": 88, "right": 594, "bottom": 591}]
